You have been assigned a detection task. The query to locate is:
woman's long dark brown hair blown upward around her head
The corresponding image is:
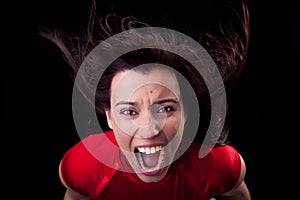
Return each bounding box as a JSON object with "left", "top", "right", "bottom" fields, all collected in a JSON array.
[{"left": 38, "top": 1, "right": 250, "bottom": 144}]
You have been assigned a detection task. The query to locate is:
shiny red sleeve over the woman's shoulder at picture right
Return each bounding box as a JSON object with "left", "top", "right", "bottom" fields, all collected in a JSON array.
[{"left": 180, "top": 144, "right": 241, "bottom": 199}]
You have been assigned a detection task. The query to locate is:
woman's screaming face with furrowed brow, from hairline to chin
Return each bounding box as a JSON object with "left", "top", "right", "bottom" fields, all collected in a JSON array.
[{"left": 106, "top": 68, "right": 185, "bottom": 182}]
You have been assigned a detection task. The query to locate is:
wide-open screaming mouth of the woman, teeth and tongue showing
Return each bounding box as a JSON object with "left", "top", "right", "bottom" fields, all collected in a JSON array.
[{"left": 134, "top": 145, "right": 166, "bottom": 175}]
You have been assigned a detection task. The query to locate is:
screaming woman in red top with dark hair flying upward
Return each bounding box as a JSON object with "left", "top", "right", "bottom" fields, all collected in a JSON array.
[{"left": 41, "top": 0, "right": 251, "bottom": 200}]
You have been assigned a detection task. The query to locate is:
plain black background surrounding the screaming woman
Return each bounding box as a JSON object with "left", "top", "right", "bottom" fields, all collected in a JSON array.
[{"left": 10, "top": 0, "right": 300, "bottom": 200}]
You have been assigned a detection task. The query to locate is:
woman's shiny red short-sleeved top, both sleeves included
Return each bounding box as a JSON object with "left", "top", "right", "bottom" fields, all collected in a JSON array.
[{"left": 61, "top": 131, "right": 241, "bottom": 200}]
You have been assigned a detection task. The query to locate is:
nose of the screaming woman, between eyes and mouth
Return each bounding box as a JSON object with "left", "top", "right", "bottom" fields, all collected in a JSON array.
[{"left": 136, "top": 113, "right": 161, "bottom": 138}]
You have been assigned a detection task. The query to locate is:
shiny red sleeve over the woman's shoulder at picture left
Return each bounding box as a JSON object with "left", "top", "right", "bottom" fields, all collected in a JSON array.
[{"left": 61, "top": 131, "right": 116, "bottom": 198}]
